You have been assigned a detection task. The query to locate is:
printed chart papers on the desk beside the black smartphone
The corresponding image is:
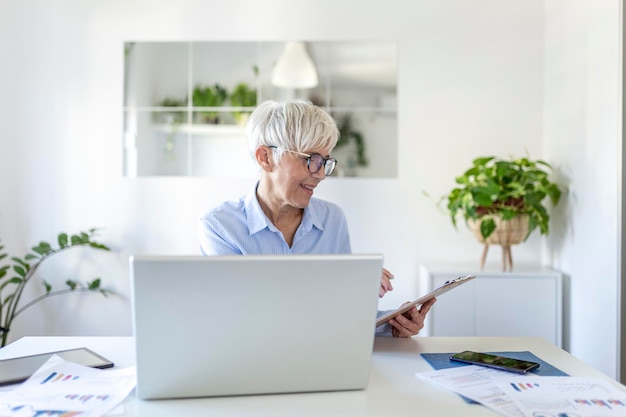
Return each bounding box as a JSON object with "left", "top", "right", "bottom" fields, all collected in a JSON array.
[{"left": 416, "top": 365, "right": 626, "bottom": 417}]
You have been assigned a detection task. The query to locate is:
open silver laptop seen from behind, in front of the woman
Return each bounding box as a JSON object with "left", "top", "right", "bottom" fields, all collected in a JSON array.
[{"left": 130, "top": 255, "right": 383, "bottom": 399}]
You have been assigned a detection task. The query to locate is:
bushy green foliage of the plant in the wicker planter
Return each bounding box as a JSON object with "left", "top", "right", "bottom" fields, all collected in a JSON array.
[{"left": 443, "top": 156, "right": 562, "bottom": 240}]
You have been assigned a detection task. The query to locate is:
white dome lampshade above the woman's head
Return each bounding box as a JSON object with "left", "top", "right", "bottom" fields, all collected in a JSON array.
[{"left": 272, "top": 42, "right": 317, "bottom": 88}]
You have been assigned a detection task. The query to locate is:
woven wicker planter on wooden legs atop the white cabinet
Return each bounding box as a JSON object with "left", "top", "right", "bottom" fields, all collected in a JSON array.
[{"left": 467, "top": 215, "right": 529, "bottom": 271}]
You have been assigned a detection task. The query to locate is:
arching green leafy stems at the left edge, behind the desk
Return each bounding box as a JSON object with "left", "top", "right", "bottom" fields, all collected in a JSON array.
[{"left": 0, "top": 229, "right": 113, "bottom": 346}]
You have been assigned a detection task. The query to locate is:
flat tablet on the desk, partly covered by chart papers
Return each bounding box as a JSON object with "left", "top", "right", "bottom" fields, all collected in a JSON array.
[{"left": 0, "top": 347, "right": 114, "bottom": 386}]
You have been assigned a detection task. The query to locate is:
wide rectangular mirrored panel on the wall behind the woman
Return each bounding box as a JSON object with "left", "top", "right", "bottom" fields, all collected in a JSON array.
[{"left": 123, "top": 41, "right": 397, "bottom": 177}]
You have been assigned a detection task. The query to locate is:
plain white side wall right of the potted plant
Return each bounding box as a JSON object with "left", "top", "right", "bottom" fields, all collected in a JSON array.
[{"left": 544, "top": 0, "right": 624, "bottom": 377}]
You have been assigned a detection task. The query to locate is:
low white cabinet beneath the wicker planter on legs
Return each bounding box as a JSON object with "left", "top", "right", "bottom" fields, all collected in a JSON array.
[{"left": 420, "top": 265, "right": 563, "bottom": 346}]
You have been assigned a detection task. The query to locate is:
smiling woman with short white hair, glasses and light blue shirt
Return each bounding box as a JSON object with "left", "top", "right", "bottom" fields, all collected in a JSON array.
[{"left": 198, "top": 100, "right": 435, "bottom": 337}]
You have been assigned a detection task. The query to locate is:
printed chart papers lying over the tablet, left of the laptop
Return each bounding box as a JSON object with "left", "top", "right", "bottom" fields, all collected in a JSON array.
[{"left": 0, "top": 355, "right": 136, "bottom": 417}]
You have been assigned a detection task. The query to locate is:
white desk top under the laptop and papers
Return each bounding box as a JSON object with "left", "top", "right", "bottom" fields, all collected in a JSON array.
[{"left": 0, "top": 337, "right": 626, "bottom": 417}]
